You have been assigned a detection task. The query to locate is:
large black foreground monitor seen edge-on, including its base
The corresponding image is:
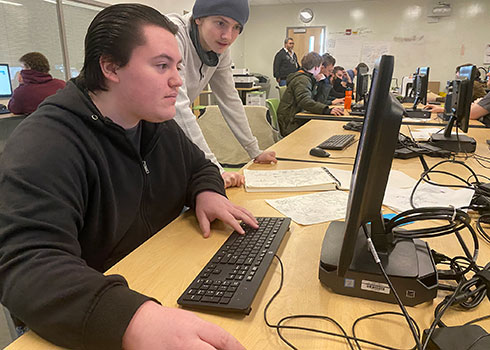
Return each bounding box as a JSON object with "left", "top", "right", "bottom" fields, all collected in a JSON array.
[{"left": 319, "top": 55, "right": 437, "bottom": 305}]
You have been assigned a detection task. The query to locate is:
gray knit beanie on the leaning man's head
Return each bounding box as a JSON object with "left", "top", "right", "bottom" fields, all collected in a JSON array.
[{"left": 192, "top": 0, "right": 249, "bottom": 28}]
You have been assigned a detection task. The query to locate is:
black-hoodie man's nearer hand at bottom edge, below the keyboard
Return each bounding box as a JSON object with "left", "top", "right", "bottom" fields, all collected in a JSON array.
[{"left": 122, "top": 301, "right": 245, "bottom": 350}]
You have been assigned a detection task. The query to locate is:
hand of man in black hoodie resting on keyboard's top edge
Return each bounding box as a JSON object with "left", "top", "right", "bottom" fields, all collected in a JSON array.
[{"left": 196, "top": 191, "right": 259, "bottom": 238}]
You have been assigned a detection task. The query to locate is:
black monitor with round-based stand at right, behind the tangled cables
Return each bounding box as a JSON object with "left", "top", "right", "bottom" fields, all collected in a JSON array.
[{"left": 431, "top": 65, "right": 477, "bottom": 153}]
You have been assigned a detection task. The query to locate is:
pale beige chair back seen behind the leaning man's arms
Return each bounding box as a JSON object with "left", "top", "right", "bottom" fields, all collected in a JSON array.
[{"left": 197, "top": 106, "right": 275, "bottom": 167}]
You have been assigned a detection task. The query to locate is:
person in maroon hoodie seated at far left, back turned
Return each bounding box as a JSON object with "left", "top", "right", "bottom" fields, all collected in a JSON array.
[{"left": 8, "top": 52, "right": 65, "bottom": 114}]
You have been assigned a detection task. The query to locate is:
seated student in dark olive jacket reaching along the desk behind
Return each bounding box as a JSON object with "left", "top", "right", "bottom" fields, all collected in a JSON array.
[{"left": 277, "top": 52, "right": 344, "bottom": 136}]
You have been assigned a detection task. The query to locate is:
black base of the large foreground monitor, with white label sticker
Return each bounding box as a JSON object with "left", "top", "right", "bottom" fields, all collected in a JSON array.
[{"left": 319, "top": 221, "right": 438, "bottom": 306}]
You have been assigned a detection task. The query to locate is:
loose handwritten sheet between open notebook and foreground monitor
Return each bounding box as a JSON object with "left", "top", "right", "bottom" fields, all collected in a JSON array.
[{"left": 266, "top": 191, "right": 349, "bottom": 225}]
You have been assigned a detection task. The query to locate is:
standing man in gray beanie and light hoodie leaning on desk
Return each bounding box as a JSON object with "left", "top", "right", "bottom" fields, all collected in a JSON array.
[{"left": 169, "top": 0, "right": 277, "bottom": 187}]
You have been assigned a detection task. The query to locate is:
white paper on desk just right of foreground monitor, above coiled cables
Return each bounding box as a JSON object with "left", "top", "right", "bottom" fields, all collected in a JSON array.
[{"left": 383, "top": 182, "right": 474, "bottom": 213}]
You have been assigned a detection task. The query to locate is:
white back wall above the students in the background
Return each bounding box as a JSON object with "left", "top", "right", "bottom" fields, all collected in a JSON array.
[{"left": 243, "top": 0, "right": 490, "bottom": 97}]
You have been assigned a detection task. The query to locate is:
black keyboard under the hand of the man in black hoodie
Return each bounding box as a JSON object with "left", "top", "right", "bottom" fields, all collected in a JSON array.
[{"left": 177, "top": 217, "right": 291, "bottom": 314}]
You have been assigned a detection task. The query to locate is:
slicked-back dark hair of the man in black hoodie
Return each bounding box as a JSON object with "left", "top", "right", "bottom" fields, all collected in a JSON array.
[{"left": 77, "top": 4, "right": 178, "bottom": 92}]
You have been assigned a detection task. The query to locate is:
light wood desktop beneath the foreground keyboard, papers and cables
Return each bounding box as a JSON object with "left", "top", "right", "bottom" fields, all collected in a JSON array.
[{"left": 7, "top": 121, "right": 490, "bottom": 350}]
